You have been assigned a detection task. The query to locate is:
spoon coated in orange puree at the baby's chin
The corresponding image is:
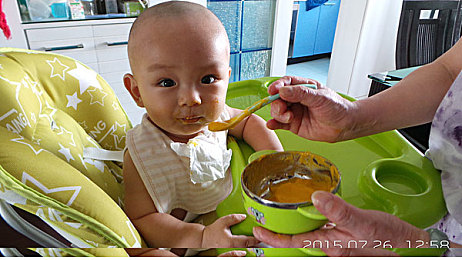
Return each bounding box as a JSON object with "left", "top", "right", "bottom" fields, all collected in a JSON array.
[{"left": 208, "top": 84, "right": 316, "bottom": 132}]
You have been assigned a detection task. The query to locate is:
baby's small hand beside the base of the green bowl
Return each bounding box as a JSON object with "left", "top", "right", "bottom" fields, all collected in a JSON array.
[{"left": 202, "top": 214, "right": 259, "bottom": 248}]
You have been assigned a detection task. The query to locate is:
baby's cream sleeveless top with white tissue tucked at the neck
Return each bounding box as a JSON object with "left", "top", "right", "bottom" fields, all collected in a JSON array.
[{"left": 127, "top": 113, "right": 233, "bottom": 214}]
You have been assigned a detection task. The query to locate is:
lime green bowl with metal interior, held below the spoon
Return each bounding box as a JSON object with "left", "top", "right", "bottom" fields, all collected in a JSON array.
[{"left": 241, "top": 151, "right": 340, "bottom": 234}]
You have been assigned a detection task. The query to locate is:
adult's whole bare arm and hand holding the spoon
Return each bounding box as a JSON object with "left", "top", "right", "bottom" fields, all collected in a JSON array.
[{"left": 267, "top": 40, "right": 462, "bottom": 142}]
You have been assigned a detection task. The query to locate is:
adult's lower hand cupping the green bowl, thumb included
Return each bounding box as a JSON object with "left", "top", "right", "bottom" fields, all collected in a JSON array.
[{"left": 253, "top": 191, "right": 429, "bottom": 256}]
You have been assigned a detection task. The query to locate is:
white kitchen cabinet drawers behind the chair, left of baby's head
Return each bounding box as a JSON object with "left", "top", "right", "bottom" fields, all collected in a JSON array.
[{"left": 24, "top": 21, "right": 132, "bottom": 95}]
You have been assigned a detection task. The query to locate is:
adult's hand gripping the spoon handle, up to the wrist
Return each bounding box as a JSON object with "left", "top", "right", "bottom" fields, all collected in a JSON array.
[{"left": 267, "top": 76, "right": 355, "bottom": 142}]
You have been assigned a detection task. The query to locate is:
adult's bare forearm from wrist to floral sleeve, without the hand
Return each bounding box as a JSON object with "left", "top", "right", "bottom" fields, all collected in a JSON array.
[{"left": 353, "top": 37, "right": 462, "bottom": 137}]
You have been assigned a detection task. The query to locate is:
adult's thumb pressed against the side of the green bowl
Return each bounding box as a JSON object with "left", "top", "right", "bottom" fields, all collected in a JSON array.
[{"left": 311, "top": 191, "right": 364, "bottom": 229}]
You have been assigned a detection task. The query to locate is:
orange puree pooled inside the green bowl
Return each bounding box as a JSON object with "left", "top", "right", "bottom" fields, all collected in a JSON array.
[{"left": 265, "top": 176, "right": 332, "bottom": 203}]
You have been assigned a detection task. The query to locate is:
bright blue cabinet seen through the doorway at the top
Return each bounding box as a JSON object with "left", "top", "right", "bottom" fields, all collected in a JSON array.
[{"left": 292, "top": 0, "right": 340, "bottom": 58}]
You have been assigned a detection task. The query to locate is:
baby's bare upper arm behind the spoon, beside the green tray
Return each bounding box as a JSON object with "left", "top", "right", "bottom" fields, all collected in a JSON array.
[{"left": 226, "top": 106, "right": 283, "bottom": 151}]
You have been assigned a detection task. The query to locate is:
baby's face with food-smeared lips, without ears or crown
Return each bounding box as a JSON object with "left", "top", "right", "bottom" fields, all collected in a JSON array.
[{"left": 130, "top": 17, "right": 230, "bottom": 140}]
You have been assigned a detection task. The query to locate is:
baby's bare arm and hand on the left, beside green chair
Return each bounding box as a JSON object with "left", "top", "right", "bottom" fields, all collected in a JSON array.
[{"left": 123, "top": 151, "right": 258, "bottom": 248}]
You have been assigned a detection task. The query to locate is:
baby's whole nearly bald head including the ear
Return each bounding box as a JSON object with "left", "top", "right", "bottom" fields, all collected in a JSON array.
[{"left": 124, "top": 1, "right": 231, "bottom": 140}]
